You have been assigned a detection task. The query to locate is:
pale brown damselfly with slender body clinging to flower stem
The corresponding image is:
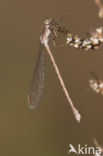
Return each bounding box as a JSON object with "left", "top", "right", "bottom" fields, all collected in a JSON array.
[{"left": 28, "top": 18, "right": 81, "bottom": 122}]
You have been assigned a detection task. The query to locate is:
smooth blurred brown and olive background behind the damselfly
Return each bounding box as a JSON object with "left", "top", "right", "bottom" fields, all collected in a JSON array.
[{"left": 0, "top": 0, "right": 103, "bottom": 156}]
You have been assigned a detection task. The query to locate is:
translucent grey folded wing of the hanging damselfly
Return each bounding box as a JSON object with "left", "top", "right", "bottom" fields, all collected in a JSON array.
[{"left": 28, "top": 43, "right": 45, "bottom": 109}]
